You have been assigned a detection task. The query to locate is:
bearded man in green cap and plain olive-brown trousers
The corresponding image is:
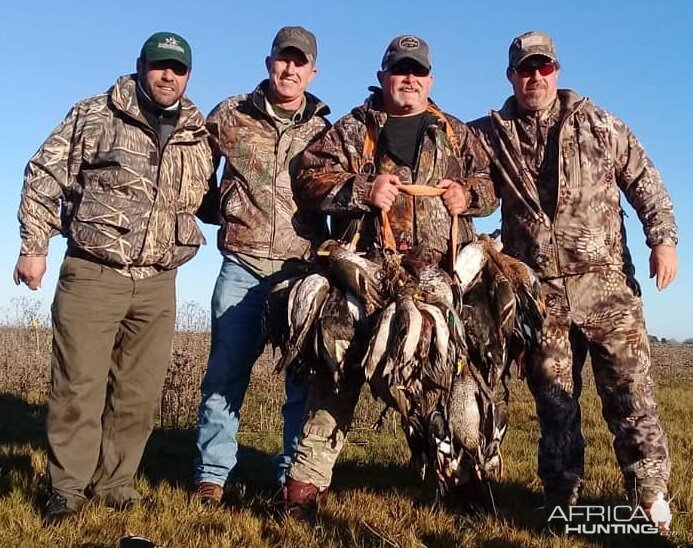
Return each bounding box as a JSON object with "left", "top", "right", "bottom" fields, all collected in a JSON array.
[{"left": 14, "top": 32, "right": 213, "bottom": 523}]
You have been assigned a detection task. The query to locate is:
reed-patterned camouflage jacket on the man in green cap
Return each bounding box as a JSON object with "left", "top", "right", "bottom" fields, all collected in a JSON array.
[{"left": 19, "top": 75, "right": 212, "bottom": 278}]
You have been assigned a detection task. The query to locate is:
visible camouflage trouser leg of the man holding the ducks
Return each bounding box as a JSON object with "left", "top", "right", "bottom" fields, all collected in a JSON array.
[{"left": 287, "top": 367, "right": 365, "bottom": 491}]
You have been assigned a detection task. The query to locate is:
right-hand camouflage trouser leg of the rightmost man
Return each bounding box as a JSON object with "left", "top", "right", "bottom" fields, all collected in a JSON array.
[{"left": 579, "top": 272, "right": 671, "bottom": 502}]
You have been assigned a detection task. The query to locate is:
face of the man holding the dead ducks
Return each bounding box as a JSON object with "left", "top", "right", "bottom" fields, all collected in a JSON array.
[{"left": 378, "top": 60, "right": 433, "bottom": 116}]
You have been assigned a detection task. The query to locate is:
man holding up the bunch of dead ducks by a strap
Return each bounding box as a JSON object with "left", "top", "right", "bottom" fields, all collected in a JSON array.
[{"left": 284, "top": 35, "right": 496, "bottom": 521}]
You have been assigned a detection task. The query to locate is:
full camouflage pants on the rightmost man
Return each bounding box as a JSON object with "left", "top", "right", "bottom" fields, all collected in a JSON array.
[{"left": 527, "top": 271, "right": 671, "bottom": 499}]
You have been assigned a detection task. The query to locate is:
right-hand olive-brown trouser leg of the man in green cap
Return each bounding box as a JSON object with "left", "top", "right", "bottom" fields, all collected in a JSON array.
[{"left": 94, "top": 270, "right": 176, "bottom": 504}]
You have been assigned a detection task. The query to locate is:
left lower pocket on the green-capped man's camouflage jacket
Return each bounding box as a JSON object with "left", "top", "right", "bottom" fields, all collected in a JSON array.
[{"left": 68, "top": 189, "right": 150, "bottom": 266}]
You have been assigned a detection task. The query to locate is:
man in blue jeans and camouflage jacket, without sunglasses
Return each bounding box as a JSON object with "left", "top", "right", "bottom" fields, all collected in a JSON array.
[{"left": 189, "top": 27, "right": 329, "bottom": 505}]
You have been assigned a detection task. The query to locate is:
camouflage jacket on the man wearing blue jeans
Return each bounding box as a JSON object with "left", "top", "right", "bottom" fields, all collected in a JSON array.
[{"left": 207, "top": 81, "right": 330, "bottom": 259}]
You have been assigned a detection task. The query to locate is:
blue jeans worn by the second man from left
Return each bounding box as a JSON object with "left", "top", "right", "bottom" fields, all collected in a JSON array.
[{"left": 194, "top": 257, "right": 308, "bottom": 485}]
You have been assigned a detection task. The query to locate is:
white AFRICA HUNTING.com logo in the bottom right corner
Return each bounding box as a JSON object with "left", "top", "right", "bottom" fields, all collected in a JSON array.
[{"left": 548, "top": 493, "right": 672, "bottom": 536}]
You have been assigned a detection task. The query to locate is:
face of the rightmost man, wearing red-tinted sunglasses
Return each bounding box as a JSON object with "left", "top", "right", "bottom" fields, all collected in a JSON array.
[{"left": 507, "top": 56, "right": 560, "bottom": 110}]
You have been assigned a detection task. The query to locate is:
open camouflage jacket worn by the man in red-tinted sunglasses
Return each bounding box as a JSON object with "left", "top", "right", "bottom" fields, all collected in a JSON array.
[{"left": 469, "top": 90, "right": 677, "bottom": 278}]
